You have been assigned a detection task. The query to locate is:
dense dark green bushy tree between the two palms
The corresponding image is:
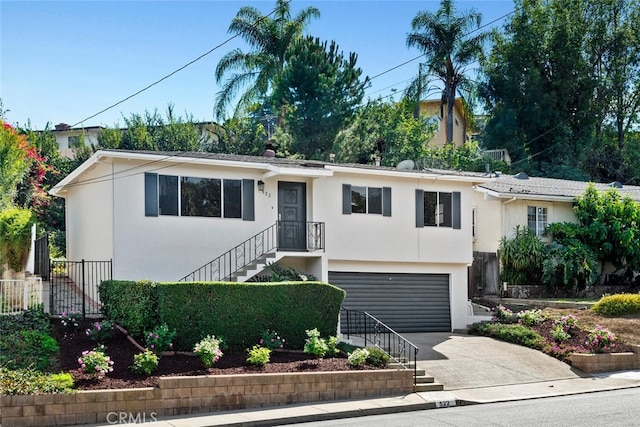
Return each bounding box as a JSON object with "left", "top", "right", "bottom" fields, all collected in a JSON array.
[{"left": 272, "top": 37, "right": 369, "bottom": 159}]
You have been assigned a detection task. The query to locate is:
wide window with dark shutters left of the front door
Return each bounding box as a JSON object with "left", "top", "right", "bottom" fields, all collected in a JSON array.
[{"left": 145, "top": 173, "right": 255, "bottom": 221}]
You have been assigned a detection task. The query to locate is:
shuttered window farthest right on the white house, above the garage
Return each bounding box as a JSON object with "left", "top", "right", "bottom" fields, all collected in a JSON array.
[{"left": 416, "top": 190, "right": 461, "bottom": 229}]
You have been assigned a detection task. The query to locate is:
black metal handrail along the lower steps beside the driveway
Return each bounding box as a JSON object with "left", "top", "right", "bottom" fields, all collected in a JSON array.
[{"left": 340, "top": 308, "right": 418, "bottom": 378}]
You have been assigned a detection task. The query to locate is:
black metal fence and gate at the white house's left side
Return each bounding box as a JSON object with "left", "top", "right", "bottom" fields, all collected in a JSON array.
[{"left": 49, "top": 260, "right": 113, "bottom": 316}]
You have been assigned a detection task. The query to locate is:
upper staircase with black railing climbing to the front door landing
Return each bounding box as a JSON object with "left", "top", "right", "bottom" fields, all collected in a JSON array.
[{"left": 179, "top": 221, "right": 324, "bottom": 282}]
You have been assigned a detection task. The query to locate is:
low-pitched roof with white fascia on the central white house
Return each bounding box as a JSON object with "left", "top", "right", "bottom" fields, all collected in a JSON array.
[{"left": 50, "top": 150, "right": 489, "bottom": 196}]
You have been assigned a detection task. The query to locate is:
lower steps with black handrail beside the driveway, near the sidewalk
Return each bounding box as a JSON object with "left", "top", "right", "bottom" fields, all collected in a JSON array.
[{"left": 340, "top": 308, "right": 444, "bottom": 392}]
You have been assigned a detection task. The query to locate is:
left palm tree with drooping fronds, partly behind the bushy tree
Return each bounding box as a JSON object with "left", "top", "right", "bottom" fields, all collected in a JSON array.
[{"left": 214, "top": 0, "right": 320, "bottom": 118}]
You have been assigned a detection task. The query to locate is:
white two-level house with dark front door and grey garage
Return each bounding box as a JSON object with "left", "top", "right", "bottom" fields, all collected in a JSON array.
[{"left": 51, "top": 150, "right": 489, "bottom": 332}]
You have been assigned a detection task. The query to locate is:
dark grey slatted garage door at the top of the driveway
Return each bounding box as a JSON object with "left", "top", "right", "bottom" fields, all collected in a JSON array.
[{"left": 329, "top": 271, "right": 451, "bottom": 332}]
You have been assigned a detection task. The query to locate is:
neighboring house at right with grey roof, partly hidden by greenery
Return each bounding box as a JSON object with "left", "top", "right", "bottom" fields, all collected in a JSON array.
[{"left": 470, "top": 172, "right": 640, "bottom": 296}]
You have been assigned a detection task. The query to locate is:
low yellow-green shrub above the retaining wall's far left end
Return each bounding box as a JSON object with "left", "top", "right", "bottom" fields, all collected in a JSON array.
[{"left": 0, "top": 368, "right": 73, "bottom": 395}]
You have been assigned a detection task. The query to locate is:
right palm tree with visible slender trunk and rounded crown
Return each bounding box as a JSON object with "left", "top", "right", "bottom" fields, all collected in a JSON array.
[{"left": 406, "top": 0, "right": 488, "bottom": 143}]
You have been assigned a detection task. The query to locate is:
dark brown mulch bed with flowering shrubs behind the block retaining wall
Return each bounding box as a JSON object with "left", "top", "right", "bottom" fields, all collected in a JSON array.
[{"left": 52, "top": 319, "right": 377, "bottom": 390}]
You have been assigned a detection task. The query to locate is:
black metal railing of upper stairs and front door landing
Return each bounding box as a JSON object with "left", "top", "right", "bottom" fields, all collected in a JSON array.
[{"left": 179, "top": 221, "right": 324, "bottom": 282}]
